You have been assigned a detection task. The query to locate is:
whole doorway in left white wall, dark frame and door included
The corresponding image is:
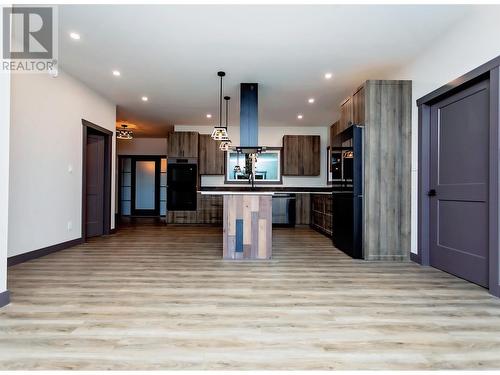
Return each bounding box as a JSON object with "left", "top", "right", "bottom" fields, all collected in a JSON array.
[{"left": 82, "top": 119, "right": 113, "bottom": 240}]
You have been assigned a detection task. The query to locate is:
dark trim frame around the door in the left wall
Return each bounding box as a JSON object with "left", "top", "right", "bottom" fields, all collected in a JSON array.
[{"left": 81, "top": 119, "right": 113, "bottom": 241}]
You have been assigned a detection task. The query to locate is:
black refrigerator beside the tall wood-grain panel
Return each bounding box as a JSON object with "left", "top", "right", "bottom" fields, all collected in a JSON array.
[{"left": 331, "top": 125, "right": 363, "bottom": 259}]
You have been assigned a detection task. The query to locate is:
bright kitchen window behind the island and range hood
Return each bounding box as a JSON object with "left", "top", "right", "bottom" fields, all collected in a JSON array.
[{"left": 226, "top": 147, "right": 281, "bottom": 184}]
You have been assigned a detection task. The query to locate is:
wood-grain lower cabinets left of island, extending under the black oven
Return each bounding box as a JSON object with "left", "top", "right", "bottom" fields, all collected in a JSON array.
[{"left": 167, "top": 193, "right": 223, "bottom": 224}]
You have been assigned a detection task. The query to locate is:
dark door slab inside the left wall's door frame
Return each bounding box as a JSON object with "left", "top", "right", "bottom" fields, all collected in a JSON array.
[{"left": 85, "top": 134, "right": 105, "bottom": 237}]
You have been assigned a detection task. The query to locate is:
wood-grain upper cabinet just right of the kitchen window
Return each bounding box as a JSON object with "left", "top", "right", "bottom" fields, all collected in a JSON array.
[{"left": 282, "top": 135, "right": 321, "bottom": 176}]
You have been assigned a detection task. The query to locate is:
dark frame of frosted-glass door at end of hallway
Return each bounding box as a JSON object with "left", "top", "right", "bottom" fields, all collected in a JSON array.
[{"left": 118, "top": 155, "right": 161, "bottom": 217}]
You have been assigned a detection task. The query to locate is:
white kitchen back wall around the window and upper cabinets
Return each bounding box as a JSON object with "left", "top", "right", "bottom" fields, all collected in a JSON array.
[{"left": 175, "top": 125, "right": 330, "bottom": 187}]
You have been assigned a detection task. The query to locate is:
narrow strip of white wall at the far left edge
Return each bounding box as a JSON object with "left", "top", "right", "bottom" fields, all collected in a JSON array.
[{"left": 0, "top": 16, "right": 11, "bottom": 293}]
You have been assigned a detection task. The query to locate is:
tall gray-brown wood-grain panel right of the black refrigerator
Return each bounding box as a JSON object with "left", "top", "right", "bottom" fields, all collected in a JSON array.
[{"left": 363, "top": 80, "right": 411, "bottom": 260}]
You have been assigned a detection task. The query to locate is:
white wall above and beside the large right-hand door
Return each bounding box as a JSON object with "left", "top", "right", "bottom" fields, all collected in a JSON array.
[{"left": 388, "top": 6, "right": 500, "bottom": 253}]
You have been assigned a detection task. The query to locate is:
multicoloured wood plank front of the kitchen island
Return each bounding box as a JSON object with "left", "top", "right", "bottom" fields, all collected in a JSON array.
[{"left": 223, "top": 194, "right": 273, "bottom": 259}]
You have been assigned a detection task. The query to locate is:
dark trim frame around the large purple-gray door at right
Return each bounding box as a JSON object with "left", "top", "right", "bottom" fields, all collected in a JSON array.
[{"left": 418, "top": 56, "right": 500, "bottom": 297}]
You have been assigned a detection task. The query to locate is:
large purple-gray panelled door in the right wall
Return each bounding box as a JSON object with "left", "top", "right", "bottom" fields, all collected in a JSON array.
[{"left": 429, "top": 81, "right": 489, "bottom": 287}]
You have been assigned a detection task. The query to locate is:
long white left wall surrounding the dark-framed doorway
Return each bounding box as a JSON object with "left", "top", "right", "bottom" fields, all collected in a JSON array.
[{"left": 8, "top": 70, "right": 116, "bottom": 256}]
